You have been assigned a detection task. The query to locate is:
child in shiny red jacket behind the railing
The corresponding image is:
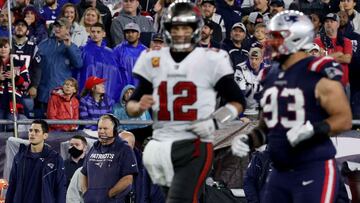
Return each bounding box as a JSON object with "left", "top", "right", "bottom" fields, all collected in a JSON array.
[{"left": 47, "top": 78, "right": 79, "bottom": 131}]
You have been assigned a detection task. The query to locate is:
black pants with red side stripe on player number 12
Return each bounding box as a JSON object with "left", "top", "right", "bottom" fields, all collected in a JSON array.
[{"left": 166, "top": 139, "right": 213, "bottom": 203}]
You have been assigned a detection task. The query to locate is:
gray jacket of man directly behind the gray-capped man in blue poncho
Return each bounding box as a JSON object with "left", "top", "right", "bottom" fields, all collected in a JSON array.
[{"left": 110, "top": 11, "right": 155, "bottom": 46}]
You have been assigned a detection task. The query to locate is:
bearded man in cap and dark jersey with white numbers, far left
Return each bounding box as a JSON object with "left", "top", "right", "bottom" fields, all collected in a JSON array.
[{"left": 13, "top": 19, "right": 41, "bottom": 118}]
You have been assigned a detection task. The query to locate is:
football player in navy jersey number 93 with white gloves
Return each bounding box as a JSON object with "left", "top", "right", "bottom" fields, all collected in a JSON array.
[{"left": 232, "top": 11, "right": 352, "bottom": 203}]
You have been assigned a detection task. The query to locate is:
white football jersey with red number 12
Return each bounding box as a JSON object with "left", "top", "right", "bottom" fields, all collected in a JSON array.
[{"left": 133, "top": 47, "right": 233, "bottom": 142}]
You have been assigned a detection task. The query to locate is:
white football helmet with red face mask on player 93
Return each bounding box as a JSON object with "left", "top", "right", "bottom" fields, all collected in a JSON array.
[{"left": 266, "top": 10, "right": 315, "bottom": 56}]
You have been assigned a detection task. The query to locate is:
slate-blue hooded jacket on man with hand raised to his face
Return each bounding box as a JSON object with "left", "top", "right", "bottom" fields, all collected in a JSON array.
[{"left": 37, "top": 37, "right": 83, "bottom": 103}]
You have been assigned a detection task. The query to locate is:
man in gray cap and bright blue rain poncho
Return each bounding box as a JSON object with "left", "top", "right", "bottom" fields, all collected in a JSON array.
[{"left": 114, "top": 23, "right": 147, "bottom": 86}]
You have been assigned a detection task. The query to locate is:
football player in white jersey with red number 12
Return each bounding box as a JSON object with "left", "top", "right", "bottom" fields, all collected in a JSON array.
[{"left": 127, "top": 1, "right": 245, "bottom": 203}]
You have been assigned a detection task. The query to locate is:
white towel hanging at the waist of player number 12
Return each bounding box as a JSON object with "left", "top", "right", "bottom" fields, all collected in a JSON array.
[{"left": 143, "top": 140, "right": 174, "bottom": 187}]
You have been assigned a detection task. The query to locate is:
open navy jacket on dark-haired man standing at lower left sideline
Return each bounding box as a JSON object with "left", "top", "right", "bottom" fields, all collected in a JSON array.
[{"left": 6, "top": 144, "right": 66, "bottom": 203}]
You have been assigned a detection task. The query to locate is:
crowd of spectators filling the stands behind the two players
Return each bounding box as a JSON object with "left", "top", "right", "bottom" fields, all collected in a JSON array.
[{"left": 0, "top": 0, "right": 360, "bottom": 202}]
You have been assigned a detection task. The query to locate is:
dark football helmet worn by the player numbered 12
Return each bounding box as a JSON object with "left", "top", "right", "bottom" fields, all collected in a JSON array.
[{"left": 162, "top": 0, "right": 204, "bottom": 51}]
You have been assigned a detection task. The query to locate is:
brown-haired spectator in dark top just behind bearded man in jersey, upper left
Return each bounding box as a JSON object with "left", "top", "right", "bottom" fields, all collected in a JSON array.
[{"left": 24, "top": 6, "right": 48, "bottom": 44}]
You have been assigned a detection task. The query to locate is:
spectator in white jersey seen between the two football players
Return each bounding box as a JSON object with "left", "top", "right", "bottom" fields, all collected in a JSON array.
[{"left": 234, "top": 47, "right": 264, "bottom": 120}]
